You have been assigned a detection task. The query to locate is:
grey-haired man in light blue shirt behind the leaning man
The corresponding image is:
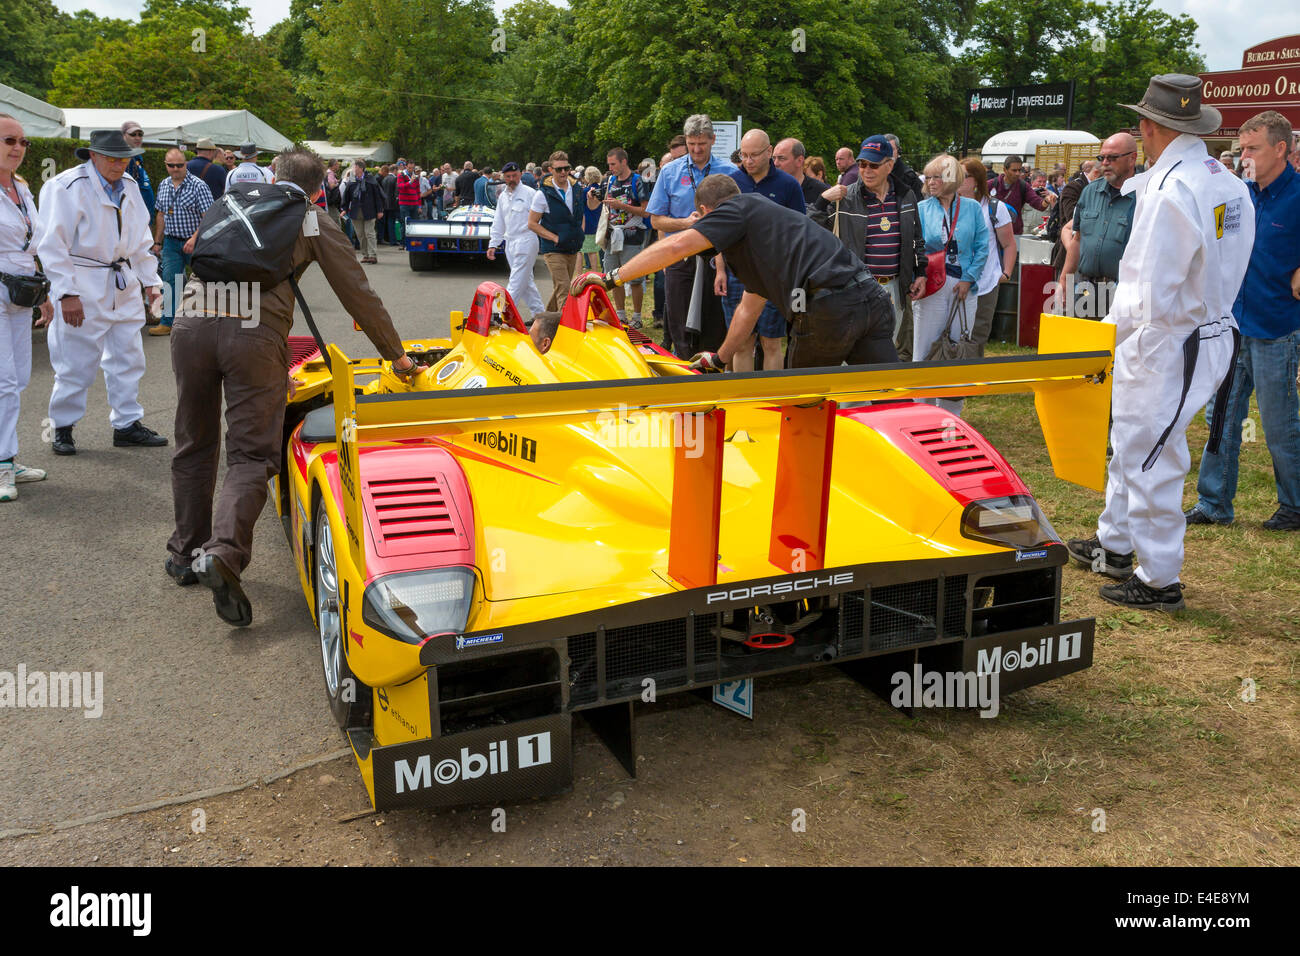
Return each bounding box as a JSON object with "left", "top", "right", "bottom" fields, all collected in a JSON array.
[{"left": 646, "top": 113, "right": 736, "bottom": 358}]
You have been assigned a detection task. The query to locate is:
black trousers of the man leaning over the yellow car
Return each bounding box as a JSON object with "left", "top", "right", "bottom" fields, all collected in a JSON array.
[{"left": 785, "top": 282, "right": 898, "bottom": 368}]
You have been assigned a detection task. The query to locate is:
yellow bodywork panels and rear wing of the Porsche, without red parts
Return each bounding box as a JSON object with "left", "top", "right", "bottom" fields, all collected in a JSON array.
[{"left": 285, "top": 304, "right": 1114, "bottom": 797}]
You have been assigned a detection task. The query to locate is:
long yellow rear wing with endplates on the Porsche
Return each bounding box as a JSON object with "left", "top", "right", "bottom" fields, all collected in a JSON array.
[{"left": 329, "top": 315, "right": 1114, "bottom": 572}]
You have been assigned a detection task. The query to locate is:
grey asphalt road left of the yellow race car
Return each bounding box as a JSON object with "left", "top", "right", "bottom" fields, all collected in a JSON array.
[{"left": 0, "top": 247, "right": 538, "bottom": 832}]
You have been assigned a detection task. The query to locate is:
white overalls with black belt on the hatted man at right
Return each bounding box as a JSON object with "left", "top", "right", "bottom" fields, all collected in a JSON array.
[{"left": 1097, "top": 133, "right": 1255, "bottom": 588}]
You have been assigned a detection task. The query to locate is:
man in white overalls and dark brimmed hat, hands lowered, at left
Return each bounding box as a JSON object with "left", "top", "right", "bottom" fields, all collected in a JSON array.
[{"left": 36, "top": 130, "right": 166, "bottom": 455}]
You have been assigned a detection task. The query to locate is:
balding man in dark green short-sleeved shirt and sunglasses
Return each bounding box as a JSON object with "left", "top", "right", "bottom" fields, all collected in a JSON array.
[{"left": 1061, "top": 133, "right": 1138, "bottom": 319}]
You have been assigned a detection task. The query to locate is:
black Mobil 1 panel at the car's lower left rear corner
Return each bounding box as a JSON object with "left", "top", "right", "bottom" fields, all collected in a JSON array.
[{"left": 372, "top": 714, "right": 572, "bottom": 809}]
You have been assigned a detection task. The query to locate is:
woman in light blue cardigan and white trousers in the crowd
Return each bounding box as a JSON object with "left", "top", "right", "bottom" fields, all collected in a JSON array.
[{"left": 911, "top": 152, "right": 988, "bottom": 415}]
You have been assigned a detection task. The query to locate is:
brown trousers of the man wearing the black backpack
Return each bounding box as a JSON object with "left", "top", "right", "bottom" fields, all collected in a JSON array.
[{"left": 166, "top": 315, "right": 289, "bottom": 574}]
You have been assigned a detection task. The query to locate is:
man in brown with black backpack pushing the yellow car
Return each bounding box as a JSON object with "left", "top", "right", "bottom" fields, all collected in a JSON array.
[{"left": 164, "top": 147, "right": 419, "bottom": 627}]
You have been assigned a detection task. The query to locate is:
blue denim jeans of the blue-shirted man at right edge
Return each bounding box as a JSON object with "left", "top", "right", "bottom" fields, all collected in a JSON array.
[{"left": 1196, "top": 330, "right": 1300, "bottom": 522}]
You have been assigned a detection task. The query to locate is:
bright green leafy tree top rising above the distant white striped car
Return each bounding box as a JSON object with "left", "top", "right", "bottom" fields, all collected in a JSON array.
[{"left": 299, "top": 0, "right": 497, "bottom": 160}]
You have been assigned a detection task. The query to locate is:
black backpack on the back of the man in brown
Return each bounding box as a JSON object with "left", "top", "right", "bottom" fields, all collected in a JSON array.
[{"left": 191, "top": 182, "right": 309, "bottom": 289}]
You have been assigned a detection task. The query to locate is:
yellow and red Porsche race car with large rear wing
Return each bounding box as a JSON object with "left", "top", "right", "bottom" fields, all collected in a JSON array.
[{"left": 273, "top": 282, "right": 1113, "bottom": 809}]
